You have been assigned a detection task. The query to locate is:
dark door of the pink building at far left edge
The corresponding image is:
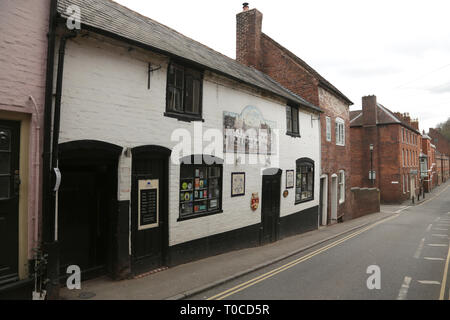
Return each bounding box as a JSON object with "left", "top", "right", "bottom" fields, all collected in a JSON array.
[{"left": 0, "top": 120, "right": 20, "bottom": 285}]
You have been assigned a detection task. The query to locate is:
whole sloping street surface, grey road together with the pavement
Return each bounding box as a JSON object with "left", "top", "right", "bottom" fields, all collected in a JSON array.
[{"left": 61, "top": 183, "right": 450, "bottom": 300}]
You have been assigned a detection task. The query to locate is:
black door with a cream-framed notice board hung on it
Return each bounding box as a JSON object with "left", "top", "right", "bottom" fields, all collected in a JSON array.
[{"left": 131, "top": 154, "right": 168, "bottom": 274}]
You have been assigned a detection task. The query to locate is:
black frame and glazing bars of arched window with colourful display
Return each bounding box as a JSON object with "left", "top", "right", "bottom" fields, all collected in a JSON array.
[{"left": 177, "top": 156, "right": 223, "bottom": 221}]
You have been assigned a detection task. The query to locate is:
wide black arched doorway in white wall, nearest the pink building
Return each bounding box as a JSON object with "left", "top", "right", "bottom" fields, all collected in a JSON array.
[{"left": 58, "top": 140, "right": 122, "bottom": 280}]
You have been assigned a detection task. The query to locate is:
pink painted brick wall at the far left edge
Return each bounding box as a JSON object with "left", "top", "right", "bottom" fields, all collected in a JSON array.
[{"left": 0, "top": 0, "right": 50, "bottom": 258}]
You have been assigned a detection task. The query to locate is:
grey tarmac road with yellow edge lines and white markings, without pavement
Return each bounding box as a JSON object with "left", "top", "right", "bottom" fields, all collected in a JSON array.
[{"left": 191, "top": 186, "right": 450, "bottom": 300}]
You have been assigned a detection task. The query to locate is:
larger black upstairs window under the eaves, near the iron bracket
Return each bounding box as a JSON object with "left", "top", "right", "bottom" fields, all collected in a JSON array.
[{"left": 165, "top": 63, "right": 203, "bottom": 121}]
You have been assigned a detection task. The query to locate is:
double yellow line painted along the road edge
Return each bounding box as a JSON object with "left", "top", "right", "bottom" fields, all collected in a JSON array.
[{"left": 207, "top": 214, "right": 400, "bottom": 300}]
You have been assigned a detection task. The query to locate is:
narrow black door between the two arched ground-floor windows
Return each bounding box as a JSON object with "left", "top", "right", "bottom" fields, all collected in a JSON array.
[{"left": 261, "top": 171, "right": 281, "bottom": 244}]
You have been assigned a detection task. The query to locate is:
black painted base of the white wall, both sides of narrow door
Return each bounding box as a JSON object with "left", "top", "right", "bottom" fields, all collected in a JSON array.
[{"left": 167, "top": 206, "right": 319, "bottom": 267}]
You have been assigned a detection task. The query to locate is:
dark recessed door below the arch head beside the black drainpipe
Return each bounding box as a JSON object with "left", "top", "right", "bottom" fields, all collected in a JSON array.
[{"left": 58, "top": 161, "right": 117, "bottom": 280}]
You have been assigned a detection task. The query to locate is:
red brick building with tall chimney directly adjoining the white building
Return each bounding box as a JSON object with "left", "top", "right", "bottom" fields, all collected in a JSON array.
[{"left": 236, "top": 6, "right": 353, "bottom": 225}]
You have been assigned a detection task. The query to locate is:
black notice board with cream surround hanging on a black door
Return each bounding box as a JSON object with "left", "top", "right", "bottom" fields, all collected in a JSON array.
[{"left": 138, "top": 180, "right": 159, "bottom": 230}]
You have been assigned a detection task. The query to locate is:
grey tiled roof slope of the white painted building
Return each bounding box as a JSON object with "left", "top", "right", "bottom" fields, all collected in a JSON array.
[{"left": 58, "top": 0, "right": 322, "bottom": 112}]
